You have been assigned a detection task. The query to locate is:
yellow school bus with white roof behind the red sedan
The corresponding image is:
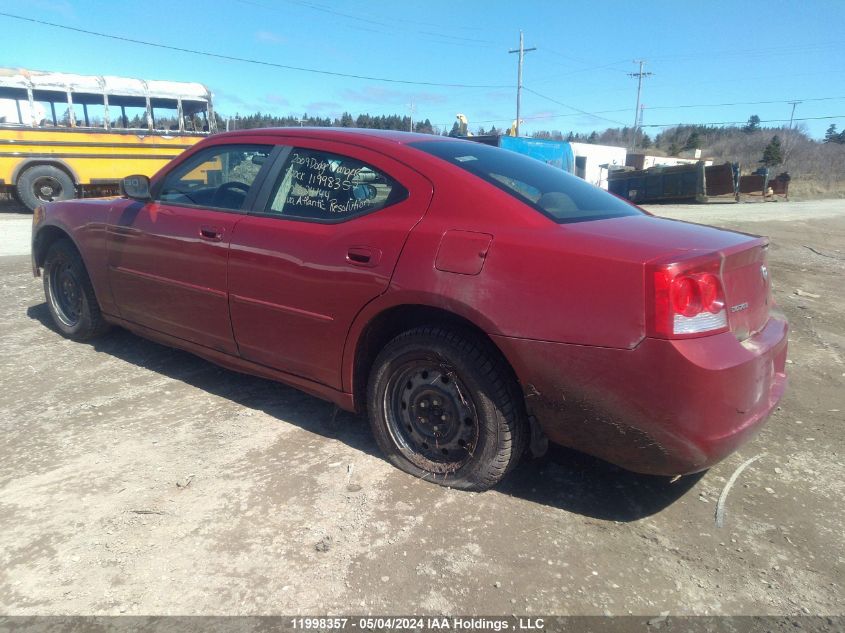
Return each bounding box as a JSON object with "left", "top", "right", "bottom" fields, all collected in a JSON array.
[{"left": 0, "top": 68, "right": 216, "bottom": 209}]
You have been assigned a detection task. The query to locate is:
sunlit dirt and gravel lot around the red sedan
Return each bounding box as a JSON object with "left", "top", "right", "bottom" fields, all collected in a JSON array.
[{"left": 0, "top": 201, "right": 845, "bottom": 614}]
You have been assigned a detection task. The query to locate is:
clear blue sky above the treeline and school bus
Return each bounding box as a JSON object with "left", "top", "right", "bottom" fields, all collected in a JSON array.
[{"left": 0, "top": 0, "right": 845, "bottom": 138}]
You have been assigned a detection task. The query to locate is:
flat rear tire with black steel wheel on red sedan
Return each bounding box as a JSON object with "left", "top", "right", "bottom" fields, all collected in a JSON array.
[{"left": 367, "top": 327, "right": 528, "bottom": 491}]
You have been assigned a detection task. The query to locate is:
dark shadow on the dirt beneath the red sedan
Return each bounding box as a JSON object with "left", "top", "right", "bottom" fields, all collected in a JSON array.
[{"left": 27, "top": 303, "right": 702, "bottom": 522}]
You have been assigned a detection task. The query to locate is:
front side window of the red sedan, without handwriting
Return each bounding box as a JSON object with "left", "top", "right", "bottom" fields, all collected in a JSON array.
[{"left": 156, "top": 145, "right": 273, "bottom": 211}]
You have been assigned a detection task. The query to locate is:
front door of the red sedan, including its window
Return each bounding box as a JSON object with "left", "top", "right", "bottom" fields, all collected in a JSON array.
[{"left": 106, "top": 142, "right": 278, "bottom": 355}]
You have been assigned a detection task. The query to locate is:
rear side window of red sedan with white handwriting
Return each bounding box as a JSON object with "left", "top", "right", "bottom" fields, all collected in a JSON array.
[{"left": 265, "top": 147, "right": 408, "bottom": 222}]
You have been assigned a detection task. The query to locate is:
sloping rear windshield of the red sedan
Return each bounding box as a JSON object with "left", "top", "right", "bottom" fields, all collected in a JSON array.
[{"left": 410, "top": 141, "right": 641, "bottom": 224}]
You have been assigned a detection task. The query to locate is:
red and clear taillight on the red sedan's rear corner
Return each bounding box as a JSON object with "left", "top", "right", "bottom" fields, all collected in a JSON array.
[{"left": 649, "top": 259, "right": 728, "bottom": 338}]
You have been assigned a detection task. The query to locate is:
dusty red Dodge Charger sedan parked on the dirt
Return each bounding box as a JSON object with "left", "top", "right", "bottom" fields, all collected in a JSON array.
[{"left": 32, "top": 129, "right": 787, "bottom": 490}]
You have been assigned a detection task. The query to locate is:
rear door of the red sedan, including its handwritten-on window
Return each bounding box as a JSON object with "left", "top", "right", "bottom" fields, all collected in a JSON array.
[{"left": 229, "top": 139, "right": 432, "bottom": 389}]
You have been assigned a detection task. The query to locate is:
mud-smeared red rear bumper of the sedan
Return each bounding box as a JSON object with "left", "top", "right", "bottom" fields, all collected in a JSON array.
[{"left": 493, "top": 313, "right": 788, "bottom": 475}]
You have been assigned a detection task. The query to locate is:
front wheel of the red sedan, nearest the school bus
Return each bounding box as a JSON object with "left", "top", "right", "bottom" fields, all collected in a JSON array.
[{"left": 43, "top": 239, "right": 108, "bottom": 341}]
